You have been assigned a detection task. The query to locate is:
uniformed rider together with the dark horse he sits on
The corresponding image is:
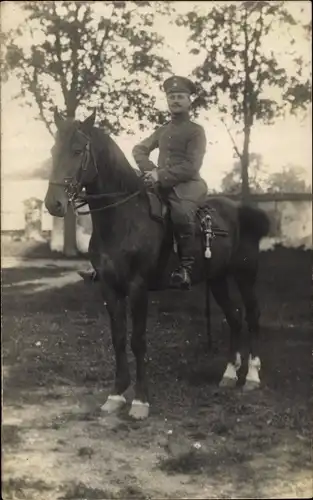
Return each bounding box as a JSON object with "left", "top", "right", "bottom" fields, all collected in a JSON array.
[{"left": 45, "top": 102, "right": 270, "bottom": 414}]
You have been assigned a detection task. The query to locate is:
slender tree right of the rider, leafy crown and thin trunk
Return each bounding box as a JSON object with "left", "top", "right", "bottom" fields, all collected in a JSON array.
[{"left": 177, "top": 1, "right": 311, "bottom": 195}]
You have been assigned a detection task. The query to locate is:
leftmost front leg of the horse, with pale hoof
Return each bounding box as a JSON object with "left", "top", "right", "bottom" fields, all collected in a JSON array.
[{"left": 101, "top": 284, "right": 130, "bottom": 413}]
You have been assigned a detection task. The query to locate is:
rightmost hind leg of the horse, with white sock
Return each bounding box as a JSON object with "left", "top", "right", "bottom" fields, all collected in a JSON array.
[{"left": 234, "top": 264, "right": 261, "bottom": 390}]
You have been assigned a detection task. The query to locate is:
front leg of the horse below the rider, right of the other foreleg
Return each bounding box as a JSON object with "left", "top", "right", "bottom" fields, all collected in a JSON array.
[{"left": 129, "top": 278, "right": 149, "bottom": 420}]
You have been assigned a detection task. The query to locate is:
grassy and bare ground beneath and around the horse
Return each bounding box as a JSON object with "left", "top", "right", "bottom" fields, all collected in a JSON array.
[{"left": 2, "top": 245, "right": 312, "bottom": 500}]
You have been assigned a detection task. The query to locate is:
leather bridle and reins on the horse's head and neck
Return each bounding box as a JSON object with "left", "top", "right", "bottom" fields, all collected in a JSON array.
[{"left": 49, "top": 129, "right": 140, "bottom": 215}]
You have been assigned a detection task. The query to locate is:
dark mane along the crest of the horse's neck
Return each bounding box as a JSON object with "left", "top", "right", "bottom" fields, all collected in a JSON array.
[{"left": 92, "top": 127, "right": 144, "bottom": 193}]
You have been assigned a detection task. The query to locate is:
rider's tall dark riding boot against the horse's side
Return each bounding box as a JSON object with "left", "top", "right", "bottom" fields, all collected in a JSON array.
[{"left": 171, "top": 224, "right": 195, "bottom": 290}]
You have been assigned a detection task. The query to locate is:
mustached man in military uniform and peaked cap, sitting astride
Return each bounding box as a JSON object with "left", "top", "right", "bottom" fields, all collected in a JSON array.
[{"left": 133, "top": 76, "right": 207, "bottom": 289}]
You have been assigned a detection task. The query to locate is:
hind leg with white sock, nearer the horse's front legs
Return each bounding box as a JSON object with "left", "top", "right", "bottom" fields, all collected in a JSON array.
[{"left": 211, "top": 275, "right": 242, "bottom": 387}]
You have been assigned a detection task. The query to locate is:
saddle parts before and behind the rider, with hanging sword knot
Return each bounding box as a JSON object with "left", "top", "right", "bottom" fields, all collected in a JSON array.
[{"left": 147, "top": 190, "right": 228, "bottom": 259}]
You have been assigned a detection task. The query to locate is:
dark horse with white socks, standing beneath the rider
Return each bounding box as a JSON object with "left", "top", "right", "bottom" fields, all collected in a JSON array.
[{"left": 45, "top": 110, "right": 269, "bottom": 419}]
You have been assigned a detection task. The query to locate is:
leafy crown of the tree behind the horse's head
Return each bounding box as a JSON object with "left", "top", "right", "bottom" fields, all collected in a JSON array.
[{"left": 5, "top": 1, "right": 170, "bottom": 134}]
